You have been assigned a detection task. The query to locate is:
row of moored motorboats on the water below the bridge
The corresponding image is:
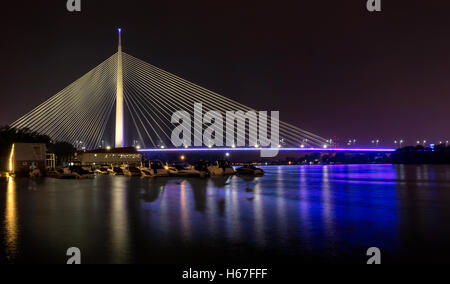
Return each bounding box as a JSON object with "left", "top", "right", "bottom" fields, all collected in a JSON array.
[{"left": 50, "top": 160, "right": 264, "bottom": 179}]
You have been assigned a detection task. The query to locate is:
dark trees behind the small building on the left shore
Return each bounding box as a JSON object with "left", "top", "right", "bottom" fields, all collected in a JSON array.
[{"left": 0, "top": 126, "right": 76, "bottom": 168}]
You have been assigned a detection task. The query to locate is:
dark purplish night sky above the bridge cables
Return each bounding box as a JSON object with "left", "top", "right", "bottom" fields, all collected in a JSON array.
[{"left": 0, "top": 0, "right": 450, "bottom": 144}]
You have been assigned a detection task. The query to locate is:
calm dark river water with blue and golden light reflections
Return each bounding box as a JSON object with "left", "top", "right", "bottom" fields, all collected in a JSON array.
[{"left": 0, "top": 165, "right": 450, "bottom": 263}]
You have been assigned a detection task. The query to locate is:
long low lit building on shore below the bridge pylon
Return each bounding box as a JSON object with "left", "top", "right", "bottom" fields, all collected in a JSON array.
[{"left": 75, "top": 147, "right": 142, "bottom": 166}]
